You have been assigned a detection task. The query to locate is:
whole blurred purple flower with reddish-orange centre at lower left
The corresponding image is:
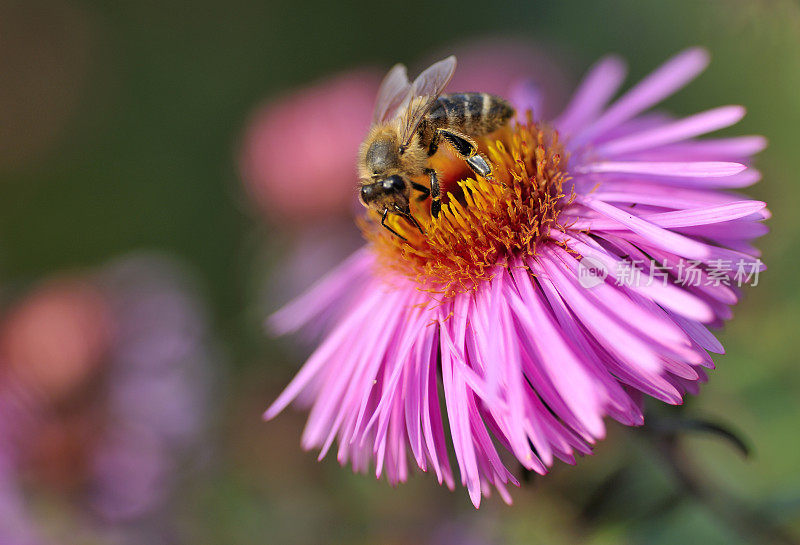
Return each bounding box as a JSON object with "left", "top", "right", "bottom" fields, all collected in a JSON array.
[{"left": 0, "top": 255, "right": 215, "bottom": 545}]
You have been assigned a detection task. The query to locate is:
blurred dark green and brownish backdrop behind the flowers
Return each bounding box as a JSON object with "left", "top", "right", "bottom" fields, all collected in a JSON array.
[{"left": 0, "top": 0, "right": 800, "bottom": 545}]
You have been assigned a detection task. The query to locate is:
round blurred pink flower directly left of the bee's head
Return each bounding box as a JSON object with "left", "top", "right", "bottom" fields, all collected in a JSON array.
[{"left": 239, "top": 69, "right": 380, "bottom": 223}]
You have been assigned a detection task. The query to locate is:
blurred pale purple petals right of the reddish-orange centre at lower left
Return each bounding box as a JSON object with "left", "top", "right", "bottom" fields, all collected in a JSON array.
[{"left": 91, "top": 256, "right": 214, "bottom": 520}]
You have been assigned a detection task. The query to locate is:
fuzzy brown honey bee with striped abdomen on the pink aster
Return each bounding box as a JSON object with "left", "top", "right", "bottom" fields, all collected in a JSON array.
[{"left": 358, "top": 56, "right": 514, "bottom": 240}]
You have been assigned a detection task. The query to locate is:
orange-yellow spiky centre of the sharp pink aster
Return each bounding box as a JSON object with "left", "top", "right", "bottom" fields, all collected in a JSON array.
[{"left": 360, "top": 116, "right": 569, "bottom": 297}]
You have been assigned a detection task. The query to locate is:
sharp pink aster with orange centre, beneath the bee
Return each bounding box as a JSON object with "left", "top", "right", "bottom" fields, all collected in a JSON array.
[{"left": 265, "top": 49, "right": 768, "bottom": 507}]
